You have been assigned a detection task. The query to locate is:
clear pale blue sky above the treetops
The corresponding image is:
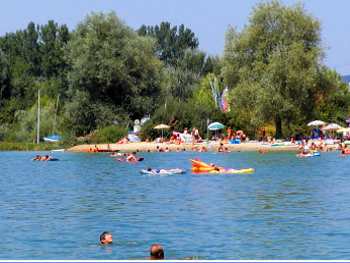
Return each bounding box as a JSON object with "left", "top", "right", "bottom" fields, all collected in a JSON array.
[{"left": 0, "top": 0, "right": 350, "bottom": 75}]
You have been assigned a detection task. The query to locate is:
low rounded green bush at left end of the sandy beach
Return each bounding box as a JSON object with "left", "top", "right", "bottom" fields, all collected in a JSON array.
[{"left": 91, "top": 125, "right": 128, "bottom": 143}]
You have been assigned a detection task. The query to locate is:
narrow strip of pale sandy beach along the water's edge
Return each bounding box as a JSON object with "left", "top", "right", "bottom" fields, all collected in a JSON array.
[{"left": 67, "top": 142, "right": 304, "bottom": 152}]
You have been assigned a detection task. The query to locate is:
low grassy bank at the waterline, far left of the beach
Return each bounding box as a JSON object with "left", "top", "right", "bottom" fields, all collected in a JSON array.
[{"left": 0, "top": 142, "right": 65, "bottom": 151}]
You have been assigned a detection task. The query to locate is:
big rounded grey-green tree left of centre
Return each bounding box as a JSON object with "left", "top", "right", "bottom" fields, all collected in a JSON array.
[{"left": 67, "top": 13, "right": 162, "bottom": 134}]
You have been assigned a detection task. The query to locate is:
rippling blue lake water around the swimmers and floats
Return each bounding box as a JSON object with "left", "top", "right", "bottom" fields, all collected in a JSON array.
[{"left": 0, "top": 152, "right": 350, "bottom": 259}]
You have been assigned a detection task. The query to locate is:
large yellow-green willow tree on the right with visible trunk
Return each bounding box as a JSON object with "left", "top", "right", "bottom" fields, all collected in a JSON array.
[{"left": 223, "top": 1, "right": 323, "bottom": 138}]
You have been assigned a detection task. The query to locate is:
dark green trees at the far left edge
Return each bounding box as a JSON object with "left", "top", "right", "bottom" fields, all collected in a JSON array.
[{"left": 0, "top": 21, "right": 69, "bottom": 126}]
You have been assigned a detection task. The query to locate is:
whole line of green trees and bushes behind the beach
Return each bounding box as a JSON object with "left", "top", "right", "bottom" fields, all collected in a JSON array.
[{"left": 0, "top": 1, "right": 350, "bottom": 142}]
